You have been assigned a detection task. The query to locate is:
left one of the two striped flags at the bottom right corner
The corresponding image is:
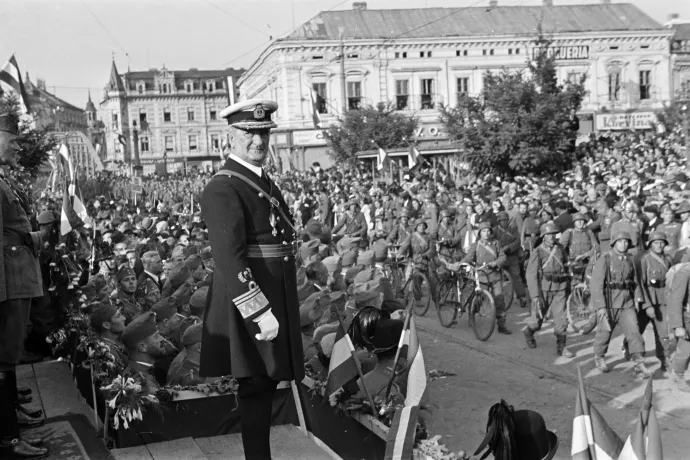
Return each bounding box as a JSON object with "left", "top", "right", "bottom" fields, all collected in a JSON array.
[{"left": 570, "top": 367, "right": 623, "bottom": 460}]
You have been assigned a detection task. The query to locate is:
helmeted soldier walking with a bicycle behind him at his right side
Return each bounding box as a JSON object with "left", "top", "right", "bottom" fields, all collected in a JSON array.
[{"left": 524, "top": 222, "right": 574, "bottom": 358}]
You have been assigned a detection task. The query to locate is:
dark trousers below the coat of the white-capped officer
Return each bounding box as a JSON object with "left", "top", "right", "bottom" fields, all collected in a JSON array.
[{"left": 237, "top": 375, "right": 278, "bottom": 460}]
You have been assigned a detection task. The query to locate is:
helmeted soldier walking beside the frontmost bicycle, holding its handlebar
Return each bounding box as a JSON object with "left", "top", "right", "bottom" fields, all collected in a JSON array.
[{"left": 462, "top": 221, "right": 511, "bottom": 334}]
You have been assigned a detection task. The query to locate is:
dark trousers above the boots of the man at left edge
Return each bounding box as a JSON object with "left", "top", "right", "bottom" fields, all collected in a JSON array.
[{"left": 0, "top": 298, "right": 31, "bottom": 371}]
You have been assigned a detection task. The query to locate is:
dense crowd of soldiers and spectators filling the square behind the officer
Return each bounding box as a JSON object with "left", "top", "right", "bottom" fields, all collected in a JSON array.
[{"left": 17, "top": 124, "right": 690, "bottom": 412}]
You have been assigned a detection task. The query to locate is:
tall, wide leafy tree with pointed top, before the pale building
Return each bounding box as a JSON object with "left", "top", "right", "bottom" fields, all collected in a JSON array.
[{"left": 440, "top": 29, "right": 586, "bottom": 176}]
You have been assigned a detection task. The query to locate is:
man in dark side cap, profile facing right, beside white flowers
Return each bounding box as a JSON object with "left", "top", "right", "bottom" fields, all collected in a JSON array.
[{"left": 122, "top": 312, "right": 165, "bottom": 393}]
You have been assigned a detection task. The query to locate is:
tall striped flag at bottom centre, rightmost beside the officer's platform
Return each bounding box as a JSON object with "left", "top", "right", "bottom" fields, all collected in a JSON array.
[{"left": 384, "top": 316, "right": 426, "bottom": 460}]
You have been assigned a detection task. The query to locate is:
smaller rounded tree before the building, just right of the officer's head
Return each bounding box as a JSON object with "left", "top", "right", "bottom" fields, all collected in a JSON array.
[{"left": 324, "top": 102, "right": 418, "bottom": 163}]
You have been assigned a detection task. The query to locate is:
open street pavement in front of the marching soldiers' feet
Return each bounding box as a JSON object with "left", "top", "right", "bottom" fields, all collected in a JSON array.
[{"left": 415, "top": 304, "right": 690, "bottom": 460}]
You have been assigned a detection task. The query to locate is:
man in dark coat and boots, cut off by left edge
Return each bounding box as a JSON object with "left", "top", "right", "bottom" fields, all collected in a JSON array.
[{"left": 0, "top": 109, "right": 48, "bottom": 458}]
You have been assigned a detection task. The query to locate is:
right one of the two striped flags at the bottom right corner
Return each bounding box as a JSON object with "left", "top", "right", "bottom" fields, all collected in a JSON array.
[{"left": 618, "top": 377, "right": 664, "bottom": 460}]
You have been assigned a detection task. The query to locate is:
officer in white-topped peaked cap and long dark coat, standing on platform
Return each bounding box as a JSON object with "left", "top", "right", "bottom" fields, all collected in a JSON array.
[{"left": 200, "top": 99, "right": 304, "bottom": 460}]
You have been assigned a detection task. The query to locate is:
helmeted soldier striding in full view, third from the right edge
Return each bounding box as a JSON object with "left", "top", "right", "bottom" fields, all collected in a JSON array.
[{"left": 590, "top": 232, "right": 651, "bottom": 377}]
